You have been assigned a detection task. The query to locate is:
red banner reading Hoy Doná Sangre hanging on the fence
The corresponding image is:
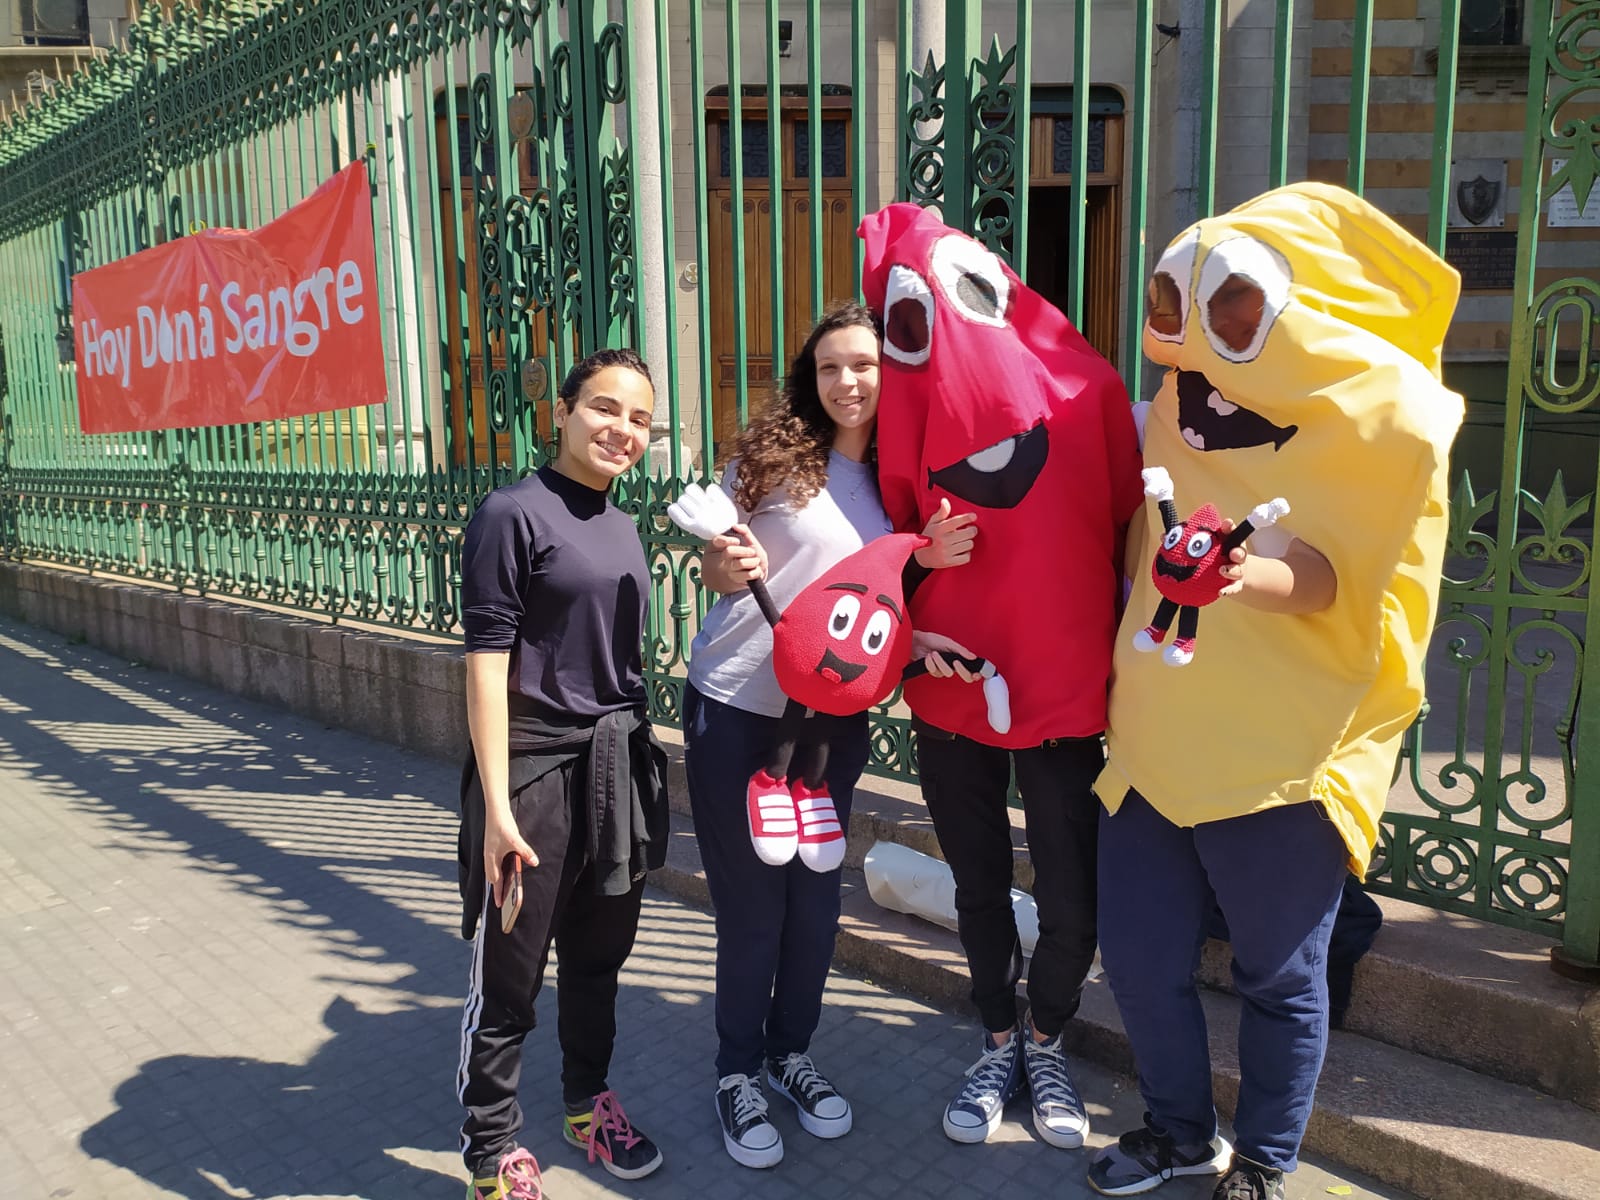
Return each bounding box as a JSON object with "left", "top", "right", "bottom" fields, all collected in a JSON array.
[{"left": 72, "top": 163, "right": 387, "bottom": 434}]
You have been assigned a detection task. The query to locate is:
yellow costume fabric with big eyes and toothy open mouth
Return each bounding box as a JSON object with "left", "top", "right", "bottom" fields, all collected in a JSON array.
[{"left": 1096, "top": 184, "right": 1462, "bottom": 875}]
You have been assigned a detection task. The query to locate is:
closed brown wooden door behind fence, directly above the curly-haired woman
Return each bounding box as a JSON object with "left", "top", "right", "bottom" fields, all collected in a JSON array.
[{"left": 706, "top": 99, "right": 856, "bottom": 456}]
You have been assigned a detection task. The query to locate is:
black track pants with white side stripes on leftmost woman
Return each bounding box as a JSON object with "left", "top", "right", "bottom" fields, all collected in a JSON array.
[{"left": 456, "top": 758, "right": 645, "bottom": 1176}]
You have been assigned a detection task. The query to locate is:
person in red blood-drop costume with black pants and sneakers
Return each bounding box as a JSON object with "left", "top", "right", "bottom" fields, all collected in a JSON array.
[{"left": 858, "top": 205, "right": 1142, "bottom": 1147}]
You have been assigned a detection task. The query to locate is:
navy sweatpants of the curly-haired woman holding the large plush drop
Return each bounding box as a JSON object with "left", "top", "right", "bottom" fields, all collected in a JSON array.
[{"left": 683, "top": 686, "right": 867, "bottom": 1078}]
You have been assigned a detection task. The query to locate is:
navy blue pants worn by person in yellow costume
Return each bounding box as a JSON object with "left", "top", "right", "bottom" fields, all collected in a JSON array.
[{"left": 1099, "top": 792, "right": 1347, "bottom": 1171}]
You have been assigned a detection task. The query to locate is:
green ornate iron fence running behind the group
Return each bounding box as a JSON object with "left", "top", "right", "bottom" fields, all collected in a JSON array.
[{"left": 0, "top": 0, "right": 1600, "bottom": 963}]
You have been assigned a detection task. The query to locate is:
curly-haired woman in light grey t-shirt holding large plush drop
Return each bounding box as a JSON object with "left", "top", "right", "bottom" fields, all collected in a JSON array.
[{"left": 683, "top": 304, "right": 974, "bottom": 1166}]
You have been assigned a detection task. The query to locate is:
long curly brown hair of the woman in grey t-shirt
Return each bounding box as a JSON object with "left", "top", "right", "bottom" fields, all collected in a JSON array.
[{"left": 731, "top": 301, "right": 883, "bottom": 512}]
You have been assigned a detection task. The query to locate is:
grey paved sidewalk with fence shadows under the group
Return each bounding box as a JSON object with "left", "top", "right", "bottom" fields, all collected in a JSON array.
[{"left": 0, "top": 619, "right": 1403, "bottom": 1200}]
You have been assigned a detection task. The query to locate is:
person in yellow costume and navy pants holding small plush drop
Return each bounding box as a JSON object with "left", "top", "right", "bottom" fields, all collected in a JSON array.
[{"left": 1090, "top": 184, "right": 1462, "bottom": 1200}]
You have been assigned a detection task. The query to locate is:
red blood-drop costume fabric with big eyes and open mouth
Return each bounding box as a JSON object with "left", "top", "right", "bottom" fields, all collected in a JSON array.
[{"left": 859, "top": 205, "right": 1144, "bottom": 749}]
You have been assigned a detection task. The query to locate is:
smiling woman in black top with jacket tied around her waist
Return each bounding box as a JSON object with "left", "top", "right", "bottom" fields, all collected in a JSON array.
[{"left": 458, "top": 350, "right": 667, "bottom": 1200}]
